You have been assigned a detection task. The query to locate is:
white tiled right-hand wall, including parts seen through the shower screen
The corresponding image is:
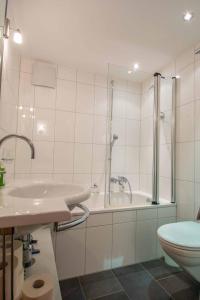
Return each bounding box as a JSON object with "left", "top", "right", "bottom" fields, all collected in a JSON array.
[{"left": 140, "top": 41, "right": 200, "bottom": 220}]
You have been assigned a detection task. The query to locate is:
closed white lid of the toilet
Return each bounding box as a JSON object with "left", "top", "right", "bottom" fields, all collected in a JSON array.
[{"left": 158, "top": 221, "right": 200, "bottom": 249}]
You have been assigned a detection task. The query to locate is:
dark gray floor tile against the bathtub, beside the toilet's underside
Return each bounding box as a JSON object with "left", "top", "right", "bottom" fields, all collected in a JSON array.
[{"left": 142, "top": 259, "right": 181, "bottom": 279}]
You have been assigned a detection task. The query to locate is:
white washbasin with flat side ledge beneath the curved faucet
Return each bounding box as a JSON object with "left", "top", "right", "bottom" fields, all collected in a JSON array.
[{"left": 0, "top": 180, "right": 90, "bottom": 228}]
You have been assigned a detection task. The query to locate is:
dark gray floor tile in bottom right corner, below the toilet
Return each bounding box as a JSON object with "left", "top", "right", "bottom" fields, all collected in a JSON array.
[{"left": 159, "top": 272, "right": 200, "bottom": 300}]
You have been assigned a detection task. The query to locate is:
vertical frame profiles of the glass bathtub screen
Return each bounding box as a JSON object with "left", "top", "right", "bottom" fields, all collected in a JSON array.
[{"left": 104, "top": 67, "right": 177, "bottom": 206}]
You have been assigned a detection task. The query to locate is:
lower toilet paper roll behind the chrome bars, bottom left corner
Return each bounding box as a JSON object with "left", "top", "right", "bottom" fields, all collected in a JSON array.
[{"left": 0, "top": 256, "right": 19, "bottom": 300}]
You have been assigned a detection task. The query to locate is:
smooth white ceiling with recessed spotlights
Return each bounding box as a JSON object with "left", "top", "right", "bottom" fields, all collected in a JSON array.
[{"left": 9, "top": 0, "right": 200, "bottom": 73}]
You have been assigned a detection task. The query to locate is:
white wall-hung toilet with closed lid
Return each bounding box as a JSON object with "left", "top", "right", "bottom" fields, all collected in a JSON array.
[{"left": 157, "top": 221, "right": 200, "bottom": 282}]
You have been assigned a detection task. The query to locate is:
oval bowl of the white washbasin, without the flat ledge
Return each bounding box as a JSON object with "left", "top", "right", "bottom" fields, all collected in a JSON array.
[{"left": 8, "top": 182, "right": 90, "bottom": 204}]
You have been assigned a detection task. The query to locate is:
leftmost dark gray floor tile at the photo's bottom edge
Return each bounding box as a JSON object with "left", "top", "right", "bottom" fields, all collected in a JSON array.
[{"left": 60, "top": 278, "right": 85, "bottom": 300}]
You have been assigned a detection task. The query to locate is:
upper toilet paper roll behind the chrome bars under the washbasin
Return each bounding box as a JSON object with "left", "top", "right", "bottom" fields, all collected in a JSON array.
[{"left": 0, "top": 240, "right": 23, "bottom": 272}]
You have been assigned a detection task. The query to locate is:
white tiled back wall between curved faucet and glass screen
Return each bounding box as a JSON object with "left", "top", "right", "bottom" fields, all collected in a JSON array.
[{"left": 1, "top": 59, "right": 107, "bottom": 188}]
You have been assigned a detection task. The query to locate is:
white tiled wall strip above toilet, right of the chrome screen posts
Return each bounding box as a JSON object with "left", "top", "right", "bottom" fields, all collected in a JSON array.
[{"left": 176, "top": 48, "right": 197, "bottom": 220}]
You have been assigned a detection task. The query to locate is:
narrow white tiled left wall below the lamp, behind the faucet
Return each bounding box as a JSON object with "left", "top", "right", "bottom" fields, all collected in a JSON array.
[{"left": 0, "top": 10, "right": 20, "bottom": 178}]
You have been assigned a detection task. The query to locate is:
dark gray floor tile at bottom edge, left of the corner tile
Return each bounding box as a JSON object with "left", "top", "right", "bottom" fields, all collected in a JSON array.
[{"left": 118, "top": 270, "right": 170, "bottom": 300}]
